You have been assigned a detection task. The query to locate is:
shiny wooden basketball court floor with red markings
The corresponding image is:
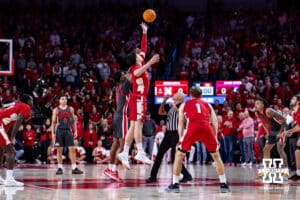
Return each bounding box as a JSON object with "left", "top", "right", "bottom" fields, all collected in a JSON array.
[{"left": 0, "top": 164, "right": 300, "bottom": 200}]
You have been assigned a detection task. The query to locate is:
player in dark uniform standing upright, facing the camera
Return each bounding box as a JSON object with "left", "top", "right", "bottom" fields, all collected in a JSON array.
[{"left": 51, "top": 95, "right": 83, "bottom": 175}]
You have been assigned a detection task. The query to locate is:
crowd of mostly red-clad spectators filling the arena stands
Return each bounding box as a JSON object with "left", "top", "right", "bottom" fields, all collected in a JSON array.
[{"left": 0, "top": 1, "right": 300, "bottom": 173}]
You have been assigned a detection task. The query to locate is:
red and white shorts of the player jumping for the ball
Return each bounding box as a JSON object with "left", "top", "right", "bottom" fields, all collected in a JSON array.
[{"left": 128, "top": 96, "right": 147, "bottom": 121}]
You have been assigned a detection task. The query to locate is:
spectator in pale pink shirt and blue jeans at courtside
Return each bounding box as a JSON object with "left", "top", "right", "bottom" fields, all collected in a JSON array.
[{"left": 238, "top": 110, "right": 254, "bottom": 167}]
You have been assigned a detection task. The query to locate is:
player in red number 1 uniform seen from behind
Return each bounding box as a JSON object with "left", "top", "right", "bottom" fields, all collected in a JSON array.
[{"left": 166, "top": 86, "right": 230, "bottom": 193}]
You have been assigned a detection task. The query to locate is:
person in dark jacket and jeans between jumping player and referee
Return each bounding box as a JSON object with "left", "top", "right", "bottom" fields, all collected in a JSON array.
[{"left": 143, "top": 112, "right": 156, "bottom": 159}]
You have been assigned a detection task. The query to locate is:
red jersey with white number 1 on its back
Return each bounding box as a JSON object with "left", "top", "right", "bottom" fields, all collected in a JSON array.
[{"left": 184, "top": 99, "right": 210, "bottom": 122}]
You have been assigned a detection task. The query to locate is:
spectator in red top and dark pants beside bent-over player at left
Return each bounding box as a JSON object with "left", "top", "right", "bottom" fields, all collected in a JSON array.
[{"left": 23, "top": 124, "right": 36, "bottom": 163}]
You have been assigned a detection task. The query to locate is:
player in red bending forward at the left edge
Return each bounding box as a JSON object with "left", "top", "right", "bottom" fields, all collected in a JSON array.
[{"left": 0, "top": 94, "right": 33, "bottom": 187}]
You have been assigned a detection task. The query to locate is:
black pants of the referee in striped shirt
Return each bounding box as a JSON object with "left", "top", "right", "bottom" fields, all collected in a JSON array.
[{"left": 151, "top": 130, "right": 191, "bottom": 179}]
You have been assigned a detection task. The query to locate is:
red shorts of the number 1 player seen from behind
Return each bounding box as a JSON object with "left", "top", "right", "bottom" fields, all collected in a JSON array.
[{"left": 179, "top": 121, "right": 219, "bottom": 153}]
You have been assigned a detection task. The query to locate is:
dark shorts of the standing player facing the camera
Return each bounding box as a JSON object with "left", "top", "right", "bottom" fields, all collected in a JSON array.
[{"left": 54, "top": 129, "right": 74, "bottom": 147}]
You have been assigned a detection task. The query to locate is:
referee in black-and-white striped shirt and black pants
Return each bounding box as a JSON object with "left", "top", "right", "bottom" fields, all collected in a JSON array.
[{"left": 146, "top": 92, "right": 192, "bottom": 183}]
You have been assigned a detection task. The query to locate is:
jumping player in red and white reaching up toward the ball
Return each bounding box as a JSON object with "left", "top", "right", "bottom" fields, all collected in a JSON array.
[{"left": 118, "top": 23, "right": 159, "bottom": 169}]
